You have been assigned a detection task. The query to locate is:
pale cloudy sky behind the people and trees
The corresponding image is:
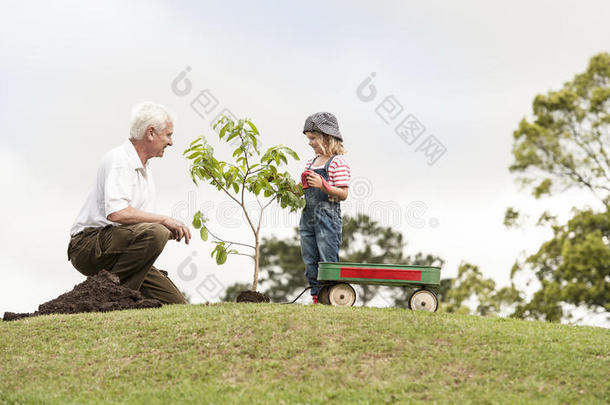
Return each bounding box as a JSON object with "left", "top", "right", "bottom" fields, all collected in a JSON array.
[{"left": 0, "top": 0, "right": 610, "bottom": 327}]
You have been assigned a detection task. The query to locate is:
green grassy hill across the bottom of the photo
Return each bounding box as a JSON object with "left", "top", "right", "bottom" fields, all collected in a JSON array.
[{"left": 0, "top": 304, "right": 610, "bottom": 404}]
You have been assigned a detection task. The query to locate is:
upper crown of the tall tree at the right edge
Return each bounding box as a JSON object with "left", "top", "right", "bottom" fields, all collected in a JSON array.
[{"left": 509, "top": 53, "right": 610, "bottom": 206}]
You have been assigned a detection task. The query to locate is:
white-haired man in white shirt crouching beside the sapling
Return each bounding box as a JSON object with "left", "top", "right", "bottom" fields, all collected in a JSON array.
[{"left": 68, "top": 102, "right": 191, "bottom": 304}]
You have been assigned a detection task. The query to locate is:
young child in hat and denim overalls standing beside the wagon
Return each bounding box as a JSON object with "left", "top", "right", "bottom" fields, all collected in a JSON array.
[{"left": 299, "top": 112, "right": 350, "bottom": 304}]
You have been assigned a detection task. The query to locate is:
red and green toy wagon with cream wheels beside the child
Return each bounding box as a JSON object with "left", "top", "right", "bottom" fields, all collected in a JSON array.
[{"left": 318, "top": 262, "right": 441, "bottom": 312}]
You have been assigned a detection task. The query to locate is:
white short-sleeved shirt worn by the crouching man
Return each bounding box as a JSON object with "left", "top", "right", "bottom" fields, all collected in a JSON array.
[{"left": 70, "top": 139, "right": 155, "bottom": 235}]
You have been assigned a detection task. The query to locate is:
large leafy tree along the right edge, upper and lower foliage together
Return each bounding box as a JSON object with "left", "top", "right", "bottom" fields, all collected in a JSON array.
[{"left": 505, "top": 53, "right": 610, "bottom": 321}]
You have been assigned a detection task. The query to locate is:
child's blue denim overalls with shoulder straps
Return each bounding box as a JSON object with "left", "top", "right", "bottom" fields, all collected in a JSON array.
[{"left": 299, "top": 155, "right": 341, "bottom": 295}]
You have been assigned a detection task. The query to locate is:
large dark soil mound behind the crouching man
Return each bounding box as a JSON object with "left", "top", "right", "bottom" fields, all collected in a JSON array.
[{"left": 3, "top": 270, "right": 161, "bottom": 321}]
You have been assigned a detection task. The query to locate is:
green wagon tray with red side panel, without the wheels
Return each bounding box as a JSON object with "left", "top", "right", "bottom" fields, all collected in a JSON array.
[{"left": 318, "top": 262, "right": 441, "bottom": 287}]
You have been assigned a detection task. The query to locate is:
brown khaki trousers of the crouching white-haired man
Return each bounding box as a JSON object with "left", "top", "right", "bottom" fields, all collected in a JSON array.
[{"left": 68, "top": 223, "right": 186, "bottom": 304}]
